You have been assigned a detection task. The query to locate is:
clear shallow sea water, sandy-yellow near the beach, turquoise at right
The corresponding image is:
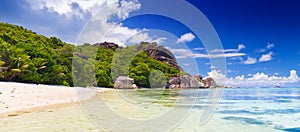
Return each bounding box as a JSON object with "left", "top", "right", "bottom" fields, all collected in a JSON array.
[{"left": 0, "top": 88, "right": 300, "bottom": 131}]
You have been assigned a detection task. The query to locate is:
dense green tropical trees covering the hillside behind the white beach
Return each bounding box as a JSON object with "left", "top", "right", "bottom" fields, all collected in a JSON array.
[{"left": 0, "top": 23, "right": 180, "bottom": 87}]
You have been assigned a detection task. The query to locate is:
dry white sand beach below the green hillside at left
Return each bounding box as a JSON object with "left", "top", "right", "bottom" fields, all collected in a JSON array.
[{"left": 0, "top": 82, "right": 110, "bottom": 117}]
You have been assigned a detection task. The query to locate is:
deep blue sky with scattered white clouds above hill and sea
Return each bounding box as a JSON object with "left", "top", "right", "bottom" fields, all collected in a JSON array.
[{"left": 0, "top": 0, "right": 300, "bottom": 86}]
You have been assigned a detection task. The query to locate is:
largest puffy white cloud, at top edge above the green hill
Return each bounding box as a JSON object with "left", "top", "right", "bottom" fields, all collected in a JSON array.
[{"left": 28, "top": 0, "right": 165, "bottom": 46}]
